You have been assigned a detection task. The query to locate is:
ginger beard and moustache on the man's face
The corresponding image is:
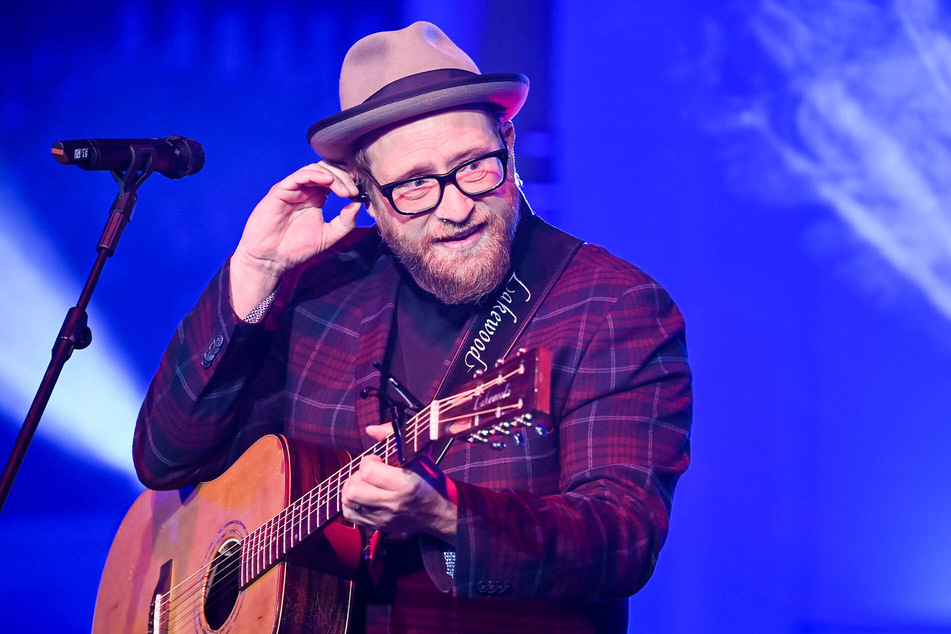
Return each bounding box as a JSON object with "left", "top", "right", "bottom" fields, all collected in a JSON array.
[{"left": 376, "top": 183, "right": 518, "bottom": 304}]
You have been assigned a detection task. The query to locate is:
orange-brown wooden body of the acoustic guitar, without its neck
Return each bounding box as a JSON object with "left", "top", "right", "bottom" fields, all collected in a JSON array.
[{"left": 92, "top": 436, "right": 362, "bottom": 634}]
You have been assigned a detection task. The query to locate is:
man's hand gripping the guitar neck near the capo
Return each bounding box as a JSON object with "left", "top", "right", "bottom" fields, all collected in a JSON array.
[{"left": 341, "top": 425, "right": 456, "bottom": 546}]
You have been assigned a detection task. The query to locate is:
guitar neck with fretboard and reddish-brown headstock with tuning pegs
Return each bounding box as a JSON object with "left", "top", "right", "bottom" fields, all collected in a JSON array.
[{"left": 240, "top": 350, "right": 550, "bottom": 588}]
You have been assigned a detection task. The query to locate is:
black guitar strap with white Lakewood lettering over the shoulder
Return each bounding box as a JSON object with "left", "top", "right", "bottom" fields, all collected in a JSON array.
[{"left": 430, "top": 198, "right": 584, "bottom": 463}]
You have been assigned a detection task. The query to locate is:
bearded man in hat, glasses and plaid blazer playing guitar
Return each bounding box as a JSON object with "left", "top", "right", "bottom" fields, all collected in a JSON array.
[{"left": 134, "top": 23, "right": 691, "bottom": 632}]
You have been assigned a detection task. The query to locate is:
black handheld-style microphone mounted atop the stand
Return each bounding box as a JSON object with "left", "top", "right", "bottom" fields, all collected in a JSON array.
[{"left": 52, "top": 136, "right": 205, "bottom": 178}]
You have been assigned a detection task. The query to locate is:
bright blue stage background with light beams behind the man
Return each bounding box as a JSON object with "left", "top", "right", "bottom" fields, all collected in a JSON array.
[{"left": 0, "top": 0, "right": 951, "bottom": 634}]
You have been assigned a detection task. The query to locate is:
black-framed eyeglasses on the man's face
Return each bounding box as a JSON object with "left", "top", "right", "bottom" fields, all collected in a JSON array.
[{"left": 356, "top": 147, "right": 509, "bottom": 216}]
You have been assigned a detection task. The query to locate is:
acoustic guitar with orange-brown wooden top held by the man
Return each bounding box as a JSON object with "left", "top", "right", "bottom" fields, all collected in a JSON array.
[{"left": 92, "top": 350, "right": 551, "bottom": 634}]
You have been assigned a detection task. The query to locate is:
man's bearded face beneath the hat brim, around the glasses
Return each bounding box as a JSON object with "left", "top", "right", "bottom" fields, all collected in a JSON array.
[{"left": 358, "top": 110, "right": 518, "bottom": 304}]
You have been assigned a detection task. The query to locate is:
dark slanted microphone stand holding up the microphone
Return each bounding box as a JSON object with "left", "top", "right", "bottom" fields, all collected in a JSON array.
[{"left": 0, "top": 145, "right": 154, "bottom": 510}]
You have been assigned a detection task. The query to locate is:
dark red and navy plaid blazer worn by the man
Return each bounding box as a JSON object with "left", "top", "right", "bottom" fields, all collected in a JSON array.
[{"left": 134, "top": 220, "right": 692, "bottom": 634}]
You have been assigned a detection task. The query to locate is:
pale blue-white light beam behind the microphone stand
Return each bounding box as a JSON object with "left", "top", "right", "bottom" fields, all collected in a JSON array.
[{"left": 0, "top": 164, "right": 145, "bottom": 478}]
